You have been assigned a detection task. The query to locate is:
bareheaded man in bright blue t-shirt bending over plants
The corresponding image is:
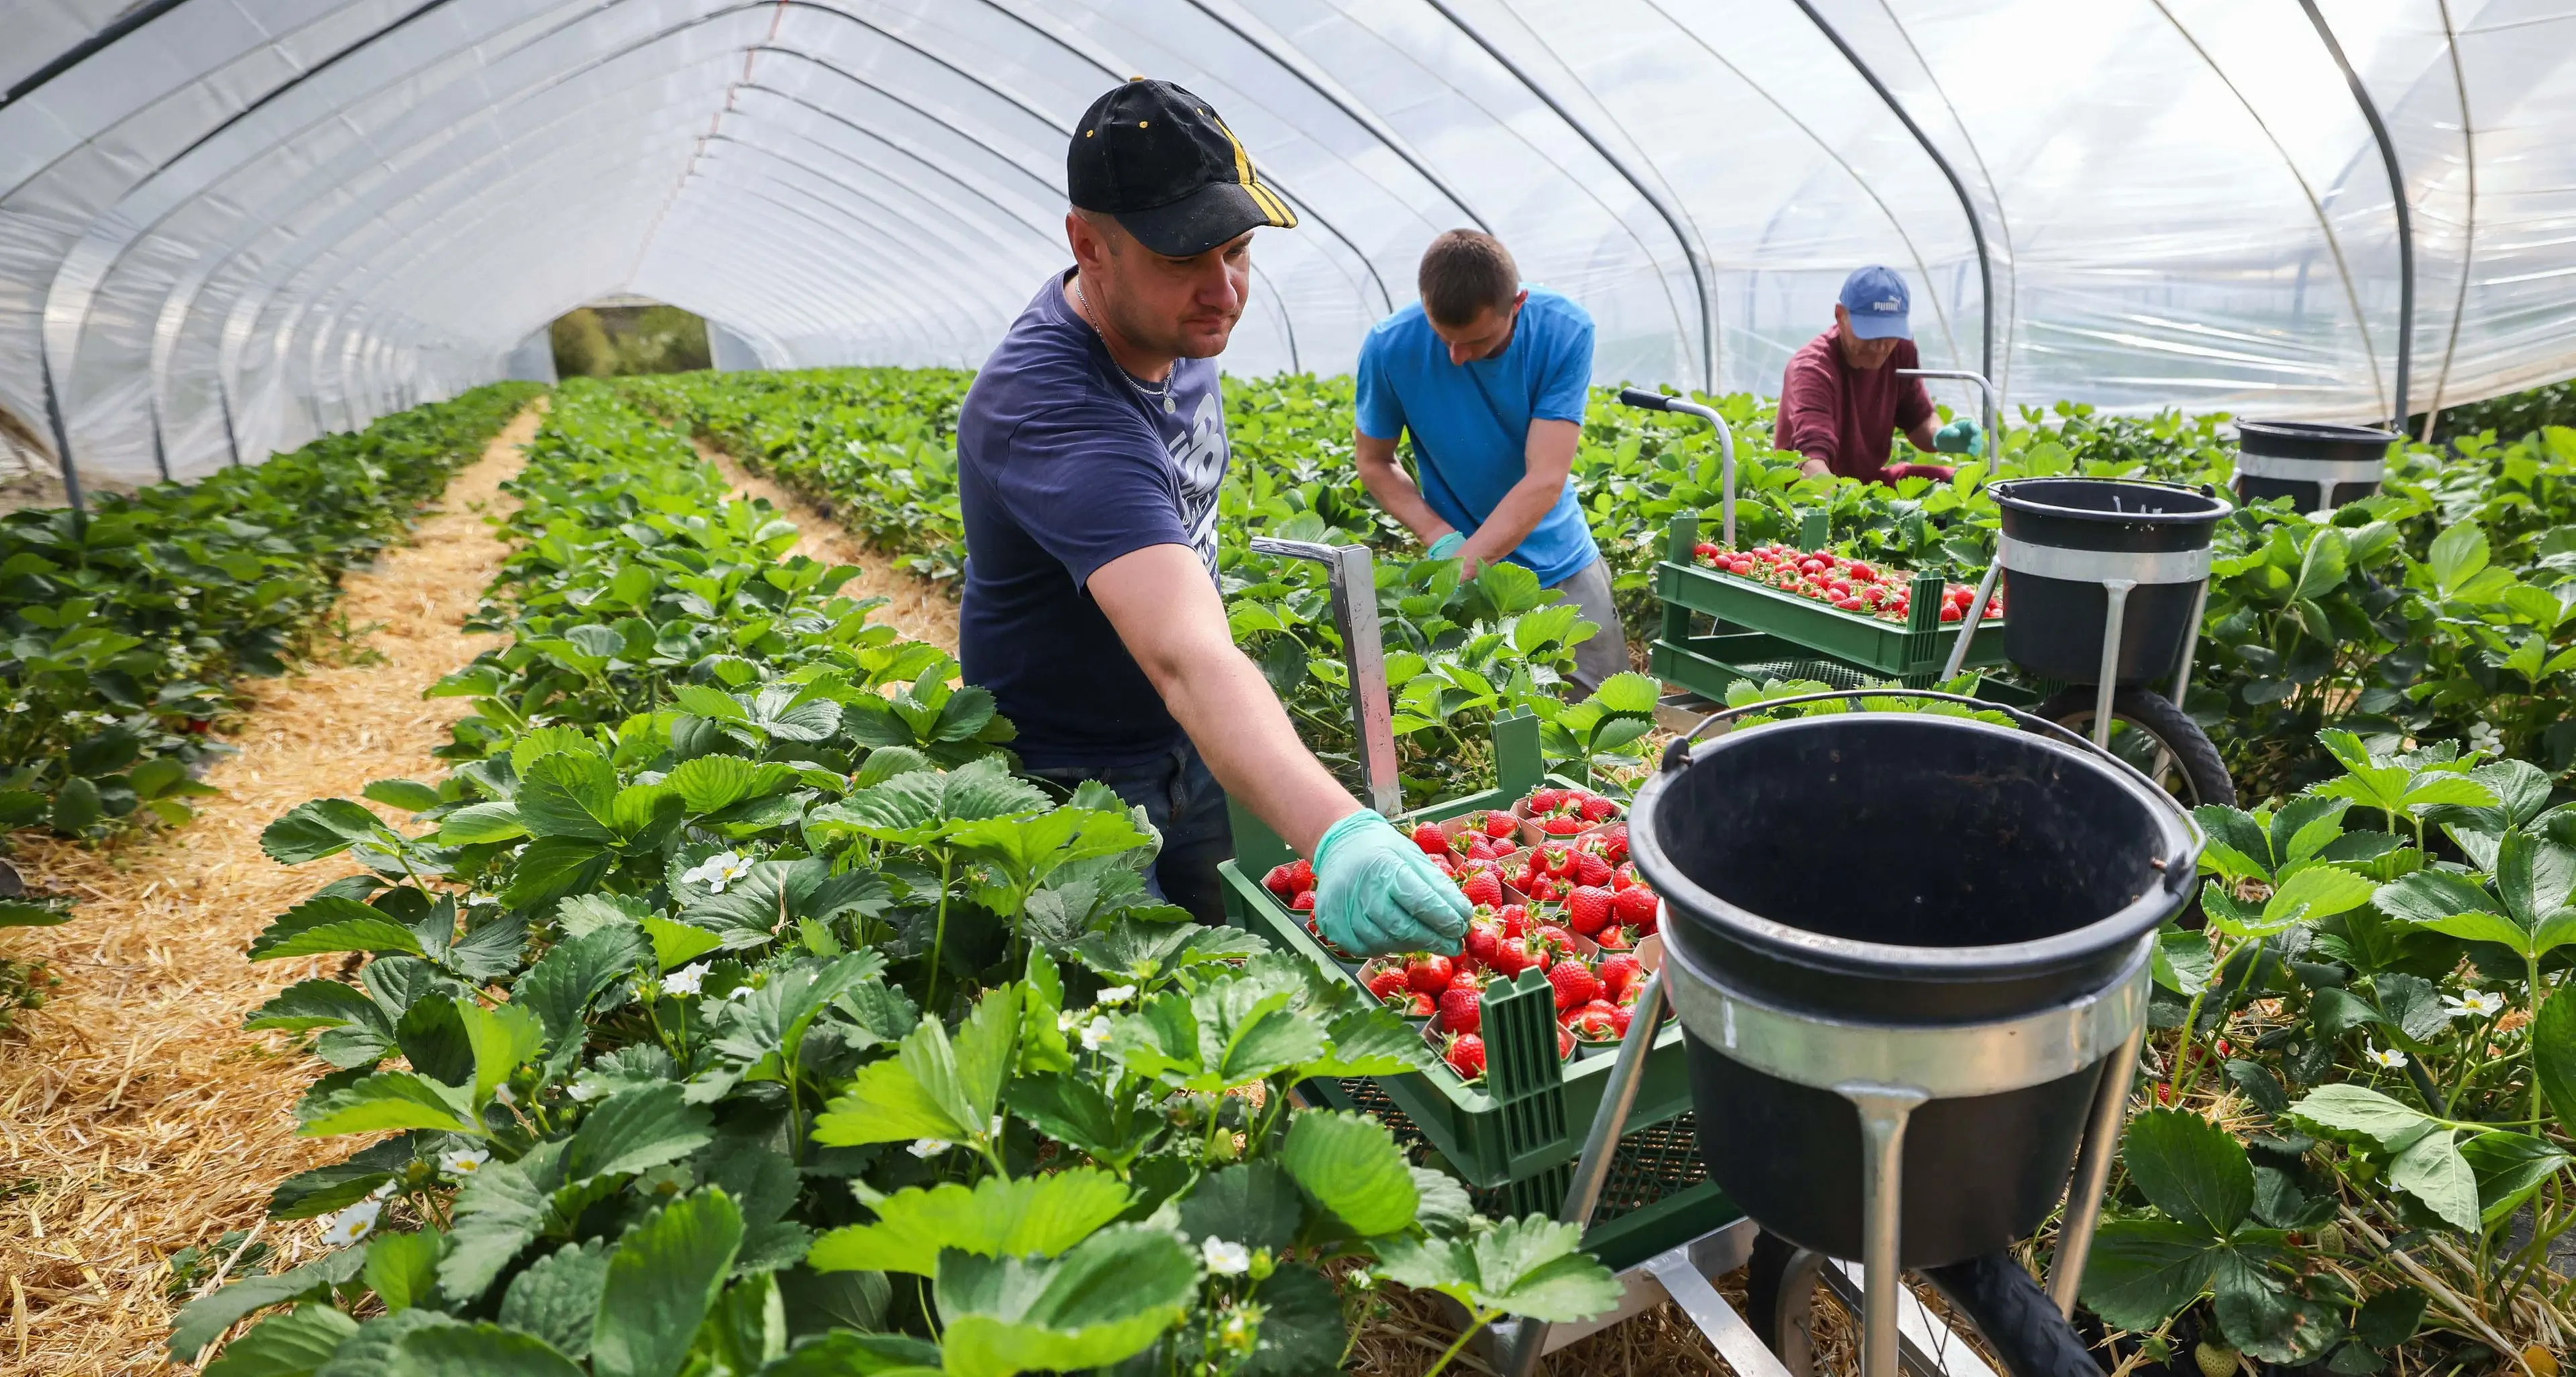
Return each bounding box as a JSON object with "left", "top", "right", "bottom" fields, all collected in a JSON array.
[{"left": 1352, "top": 229, "right": 1628, "bottom": 692}]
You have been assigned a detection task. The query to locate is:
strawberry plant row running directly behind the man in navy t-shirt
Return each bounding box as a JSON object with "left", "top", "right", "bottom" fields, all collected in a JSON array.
[{"left": 621, "top": 368, "right": 1654, "bottom": 803}]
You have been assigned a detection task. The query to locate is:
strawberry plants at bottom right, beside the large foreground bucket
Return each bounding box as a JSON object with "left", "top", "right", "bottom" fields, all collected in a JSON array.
[{"left": 2084, "top": 731, "right": 2576, "bottom": 1377}]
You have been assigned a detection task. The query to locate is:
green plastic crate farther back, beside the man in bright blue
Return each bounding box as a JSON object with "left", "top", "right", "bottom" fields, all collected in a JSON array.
[{"left": 1654, "top": 512, "right": 2004, "bottom": 698}]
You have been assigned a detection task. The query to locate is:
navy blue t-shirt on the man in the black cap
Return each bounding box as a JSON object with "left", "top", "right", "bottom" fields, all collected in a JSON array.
[{"left": 958, "top": 276, "right": 1226, "bottom": 769}]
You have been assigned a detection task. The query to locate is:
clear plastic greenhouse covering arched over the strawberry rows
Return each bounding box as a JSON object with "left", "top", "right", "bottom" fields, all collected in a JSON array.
[{"left": 0, "top": 0, "right": 2576, "bottom": 482}]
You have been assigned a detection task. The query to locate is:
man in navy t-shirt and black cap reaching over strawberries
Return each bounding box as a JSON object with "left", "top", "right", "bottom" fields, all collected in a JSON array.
[{"left": 958, "top": 80, "right": 1468, "bottom": 952}]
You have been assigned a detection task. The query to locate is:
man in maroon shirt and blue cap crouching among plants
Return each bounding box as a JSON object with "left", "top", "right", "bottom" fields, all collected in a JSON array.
[{"left": 1772, "top": 268, "right": 1976, "bottom": 484}]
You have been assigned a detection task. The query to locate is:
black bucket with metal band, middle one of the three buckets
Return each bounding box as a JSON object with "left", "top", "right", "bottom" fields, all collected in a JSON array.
[{"left": 1991, "top": 479, "right": 2229, "bottom": 685}]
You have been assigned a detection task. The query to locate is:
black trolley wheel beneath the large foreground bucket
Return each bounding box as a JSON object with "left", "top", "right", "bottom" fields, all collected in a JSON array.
[{"left": 1744, "top": 1233, "right": 2102, "bottom": 1377}]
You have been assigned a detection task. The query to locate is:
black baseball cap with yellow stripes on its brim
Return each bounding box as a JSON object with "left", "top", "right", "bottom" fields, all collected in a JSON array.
[{"left": 1064, "top": 77, "right": 1296, "bottom": 258}]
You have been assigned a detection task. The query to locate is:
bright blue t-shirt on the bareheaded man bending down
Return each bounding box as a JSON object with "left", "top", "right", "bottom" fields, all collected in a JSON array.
[{"left": 1358, "top": 286, "right": 1600, "bottom": 587}]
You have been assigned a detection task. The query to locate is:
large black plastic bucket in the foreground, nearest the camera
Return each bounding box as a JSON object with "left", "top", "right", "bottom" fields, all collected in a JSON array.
[{"left": 1628, "top": 713, "right": 2198, "bottom": 1266}]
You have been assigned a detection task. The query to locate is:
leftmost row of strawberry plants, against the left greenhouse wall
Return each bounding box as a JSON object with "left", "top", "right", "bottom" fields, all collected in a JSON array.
[{"left": 0, "top": 384, "right": 539, "bottom": 836}]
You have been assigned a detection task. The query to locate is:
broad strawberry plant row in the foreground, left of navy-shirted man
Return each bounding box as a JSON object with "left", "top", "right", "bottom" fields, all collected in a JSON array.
[{"left": 186, "top": 384, "right": 1618, "bottom": 1377}]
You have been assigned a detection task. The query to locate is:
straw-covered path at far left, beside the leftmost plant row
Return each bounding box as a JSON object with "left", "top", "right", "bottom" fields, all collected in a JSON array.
[{"left": 0, "top": 409, "right": 539, "bottom": 1377}]
